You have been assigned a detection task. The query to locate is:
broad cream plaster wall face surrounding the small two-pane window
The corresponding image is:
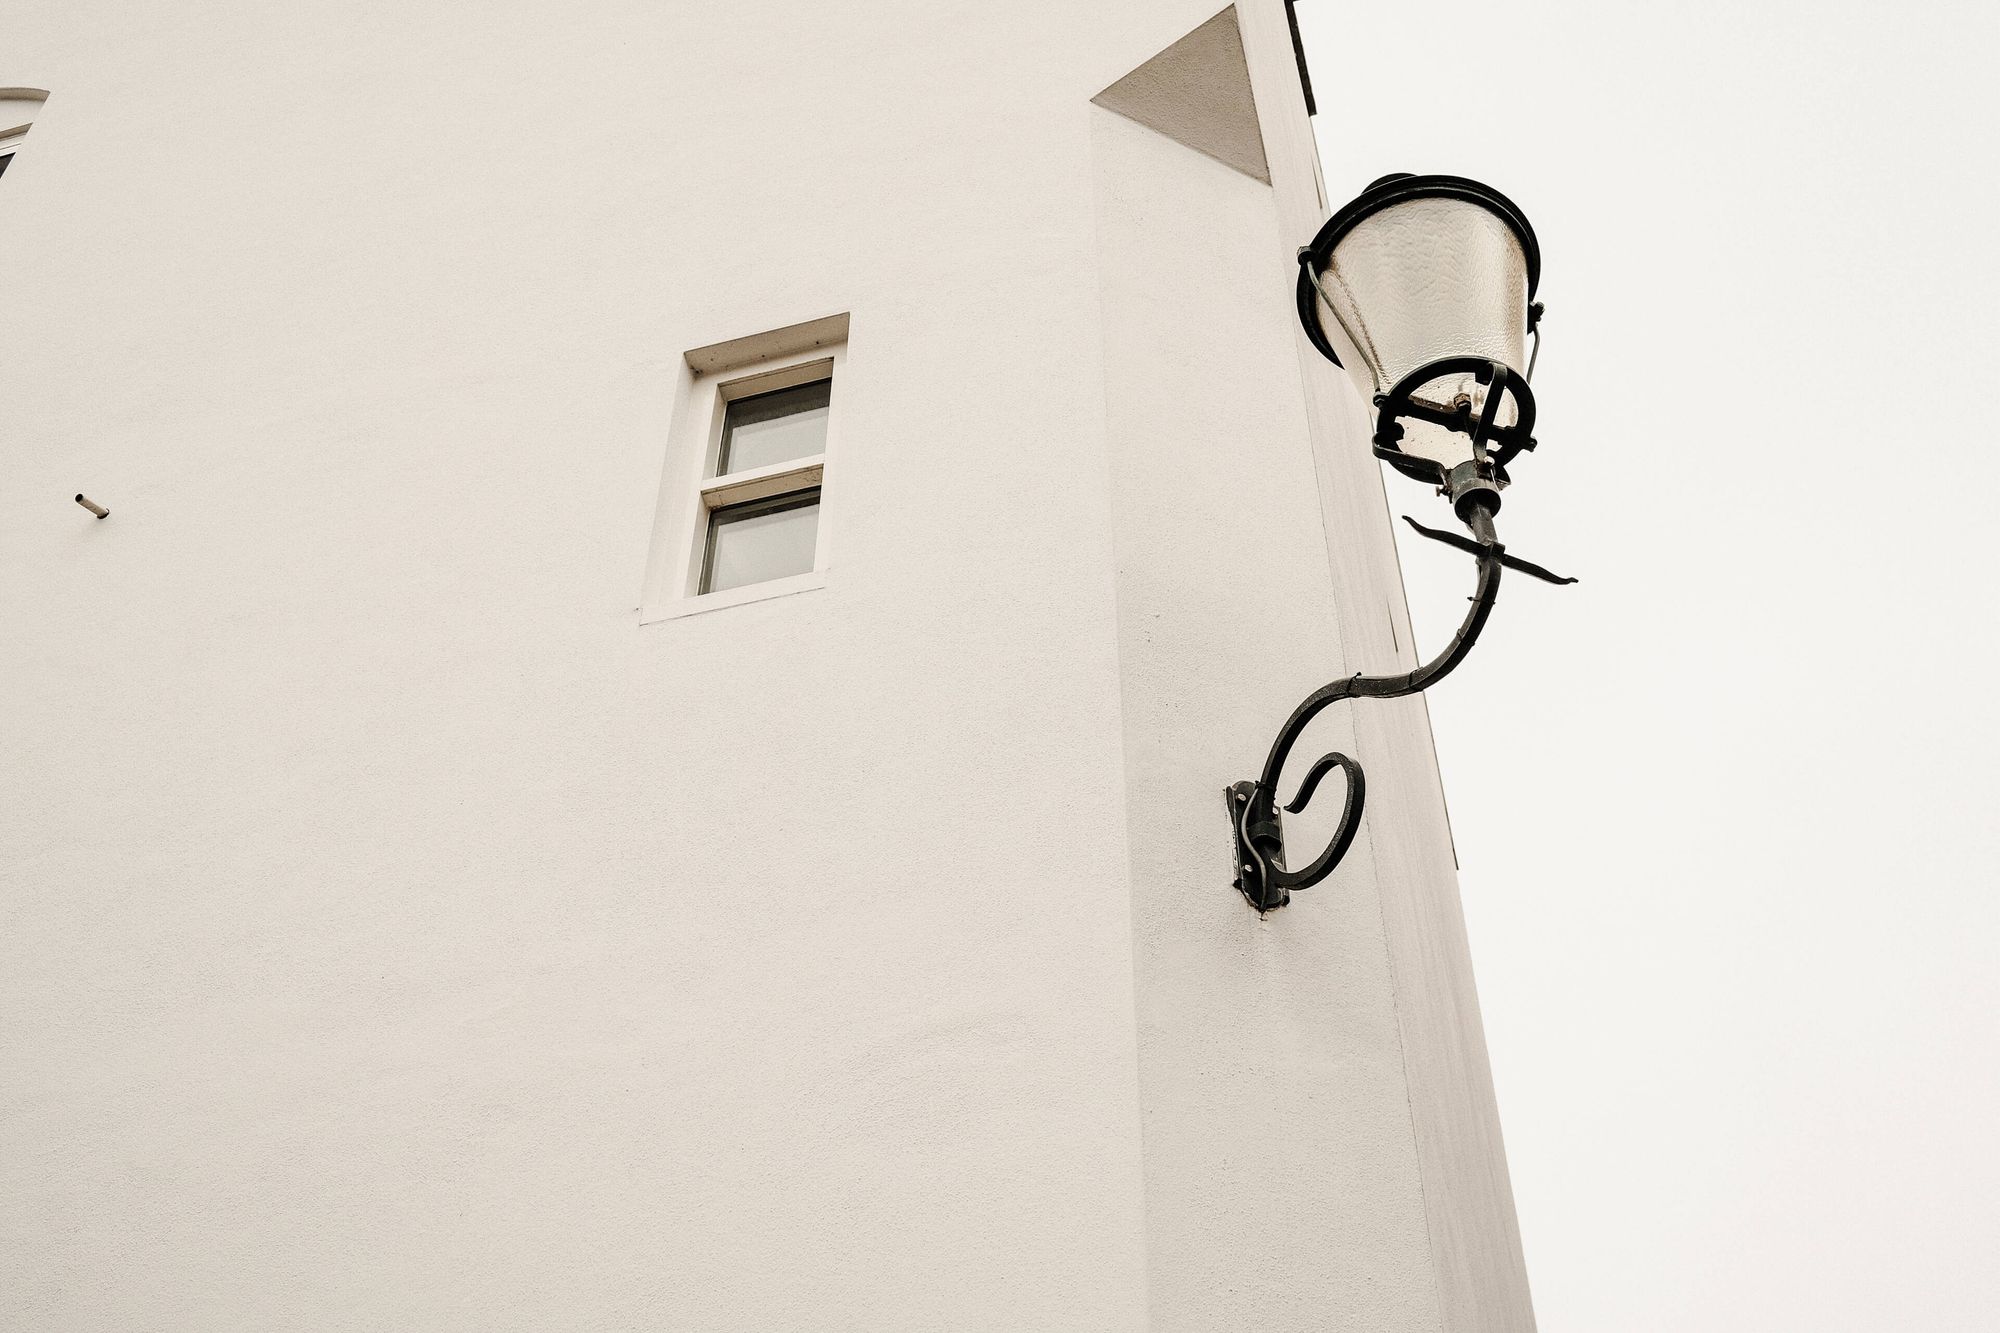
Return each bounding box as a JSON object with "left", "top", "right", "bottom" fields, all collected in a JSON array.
[{"left": 0, "top": 0, "right": 1144, "bottom": 1329}]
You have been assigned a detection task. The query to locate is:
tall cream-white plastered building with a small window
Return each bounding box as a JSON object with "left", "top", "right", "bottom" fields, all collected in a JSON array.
[{"left": 0, "top": 0, "right": 1532, "bottom": 1333}]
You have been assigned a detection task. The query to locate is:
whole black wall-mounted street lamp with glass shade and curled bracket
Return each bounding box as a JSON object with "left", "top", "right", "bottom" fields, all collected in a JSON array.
[{"left": 1226, "top": 174, "right": 1576, "bottom": 913}]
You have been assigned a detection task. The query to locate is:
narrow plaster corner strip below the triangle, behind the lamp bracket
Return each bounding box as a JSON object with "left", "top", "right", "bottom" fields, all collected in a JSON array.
[{"left": 1096, "top": 114, "right": 1438, "bottom": 1331}]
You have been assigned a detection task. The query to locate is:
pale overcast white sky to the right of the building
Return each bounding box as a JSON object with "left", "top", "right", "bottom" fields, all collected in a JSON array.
[{"left": 1300, "top": 0, "right": 2000, "bottom": 1333}]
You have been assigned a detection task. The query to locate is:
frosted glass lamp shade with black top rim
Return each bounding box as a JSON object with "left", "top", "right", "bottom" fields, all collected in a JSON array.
[{"left": 1298, "top": 176, "right": 1542, "bottom": 466}]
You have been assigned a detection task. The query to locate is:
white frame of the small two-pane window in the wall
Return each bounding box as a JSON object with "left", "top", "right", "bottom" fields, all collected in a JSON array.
[{"left": 640, "top": 334, "right": 846, "bottom": 624}]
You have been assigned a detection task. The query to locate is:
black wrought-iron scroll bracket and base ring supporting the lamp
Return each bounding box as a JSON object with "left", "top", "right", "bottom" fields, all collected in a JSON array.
[{"left": 1224, "top": 358, "right": 1576, "bottom": 913}]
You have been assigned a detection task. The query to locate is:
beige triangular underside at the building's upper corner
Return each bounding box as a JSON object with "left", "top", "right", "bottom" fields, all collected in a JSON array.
[{"left": 1090, "top": 4, "right": 1270, "bottom": 184}]
